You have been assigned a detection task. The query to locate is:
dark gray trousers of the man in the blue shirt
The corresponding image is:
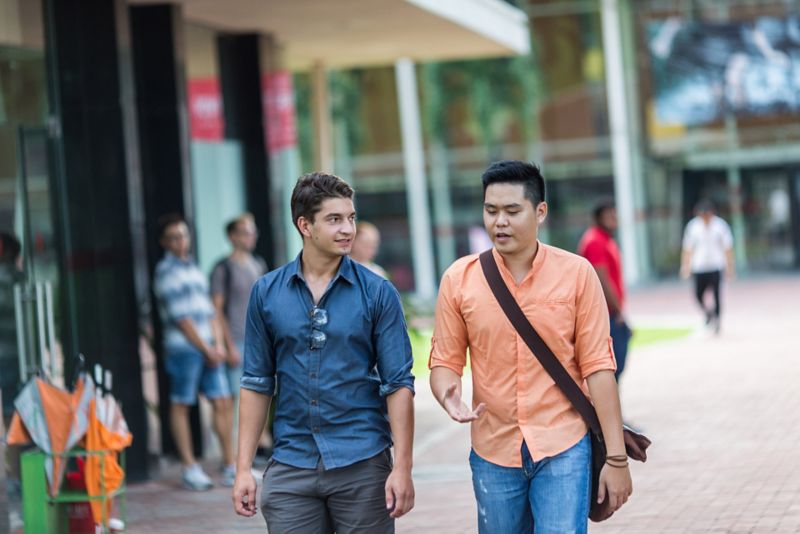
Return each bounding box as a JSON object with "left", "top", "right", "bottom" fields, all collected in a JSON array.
[{"left": 261, "top": 449, "right": 394, "bottom": 534}]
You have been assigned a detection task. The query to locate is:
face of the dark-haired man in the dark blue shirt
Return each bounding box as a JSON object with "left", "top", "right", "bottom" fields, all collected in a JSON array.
[{"left": 297, "top": 198, "right": 356, "bottom": 256}]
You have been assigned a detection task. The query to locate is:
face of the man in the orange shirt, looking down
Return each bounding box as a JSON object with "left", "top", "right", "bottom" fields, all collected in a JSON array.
[{"left": 483, "top": 183, "right": 547, "bottom": 255}]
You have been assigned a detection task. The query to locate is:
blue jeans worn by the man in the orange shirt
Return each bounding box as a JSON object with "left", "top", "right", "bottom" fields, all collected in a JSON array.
[{"left": 469, "top": 434, "right": 592, "bottom": 534}]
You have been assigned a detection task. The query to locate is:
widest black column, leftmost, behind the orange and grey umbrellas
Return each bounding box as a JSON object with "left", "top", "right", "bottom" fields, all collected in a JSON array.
[{"left": 44, "top": 0, "right": 148, "bottom": 480}]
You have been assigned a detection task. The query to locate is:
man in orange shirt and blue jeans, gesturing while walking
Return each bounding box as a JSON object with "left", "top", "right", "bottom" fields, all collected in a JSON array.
[{"left": 429, "top": 161, "right": 632, "bottom": 534}]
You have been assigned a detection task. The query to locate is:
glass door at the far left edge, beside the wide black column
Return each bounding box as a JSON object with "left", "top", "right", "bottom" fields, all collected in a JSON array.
[{"left": 0, "top": 38, "right": 63, "bottom": 422}]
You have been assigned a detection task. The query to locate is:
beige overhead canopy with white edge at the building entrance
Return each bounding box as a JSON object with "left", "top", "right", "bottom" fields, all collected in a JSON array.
[{"left": 130, "top": 0, "right": 530, "bottom": 69}]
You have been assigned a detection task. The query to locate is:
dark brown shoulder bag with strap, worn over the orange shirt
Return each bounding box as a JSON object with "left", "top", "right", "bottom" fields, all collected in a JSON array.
[{"left": 480, "top": 249, "right": 650, "bottom": 522}]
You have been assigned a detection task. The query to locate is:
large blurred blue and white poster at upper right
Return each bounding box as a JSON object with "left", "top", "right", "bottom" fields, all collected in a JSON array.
[{"left": 646, "top": 16, "right": 800, "bottom": 126}]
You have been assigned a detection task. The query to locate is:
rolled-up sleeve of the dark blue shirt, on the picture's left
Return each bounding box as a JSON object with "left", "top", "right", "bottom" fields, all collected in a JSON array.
[{"left": 240, "top": 279, "right": 275, "bottom": 397}]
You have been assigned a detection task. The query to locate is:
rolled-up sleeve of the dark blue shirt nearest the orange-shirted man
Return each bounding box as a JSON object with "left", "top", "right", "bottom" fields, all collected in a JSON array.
[{"left": 372, "top": 281, "right": 414, "bottom": 397}]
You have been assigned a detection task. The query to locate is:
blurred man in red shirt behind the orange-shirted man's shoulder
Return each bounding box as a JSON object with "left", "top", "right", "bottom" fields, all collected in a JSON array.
[{"left": 578, "top": 200, "right": 631, "bottom": 381}]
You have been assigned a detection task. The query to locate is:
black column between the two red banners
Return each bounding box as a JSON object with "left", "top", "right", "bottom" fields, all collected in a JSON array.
[{"left": 217, "top": 34, "right": 275, "bottom": 268}]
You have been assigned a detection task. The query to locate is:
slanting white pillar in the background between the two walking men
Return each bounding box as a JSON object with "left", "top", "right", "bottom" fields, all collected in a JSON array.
[{"left": 395, "top": 58, "right": 436, "bottom": 299}]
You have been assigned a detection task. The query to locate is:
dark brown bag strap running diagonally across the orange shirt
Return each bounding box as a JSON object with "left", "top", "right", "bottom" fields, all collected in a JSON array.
[{"left": 480, "top": 249, "right": 603, "bottom": 437}]
